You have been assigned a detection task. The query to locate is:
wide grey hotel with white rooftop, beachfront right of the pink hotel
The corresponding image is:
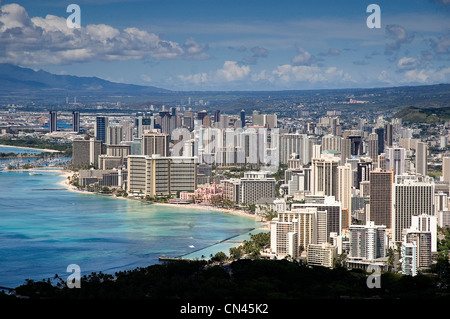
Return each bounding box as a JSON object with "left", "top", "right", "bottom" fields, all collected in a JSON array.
[{"left": 240, "top": 171, "right": 276, "bottom": 205}]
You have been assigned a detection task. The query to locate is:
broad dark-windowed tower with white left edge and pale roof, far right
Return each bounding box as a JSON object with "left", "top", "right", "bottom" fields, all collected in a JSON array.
[{"left": 391, "top": 175, "right": 435, "bottom": 242}]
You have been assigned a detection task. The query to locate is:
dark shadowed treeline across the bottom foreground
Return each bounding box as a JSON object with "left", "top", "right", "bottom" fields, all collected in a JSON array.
[{"left": 0, "top": 259, "right": 450, "bottom": 300}]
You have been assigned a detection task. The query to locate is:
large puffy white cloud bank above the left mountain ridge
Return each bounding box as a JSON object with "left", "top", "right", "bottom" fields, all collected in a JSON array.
[{"left": 0, "top": 4, "right": 210, "bottom": 65}]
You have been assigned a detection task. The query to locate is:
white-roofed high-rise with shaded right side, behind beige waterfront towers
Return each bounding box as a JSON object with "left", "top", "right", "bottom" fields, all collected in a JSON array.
[{"left": 291, "top": 195, "right": 342, "bottom": 244}]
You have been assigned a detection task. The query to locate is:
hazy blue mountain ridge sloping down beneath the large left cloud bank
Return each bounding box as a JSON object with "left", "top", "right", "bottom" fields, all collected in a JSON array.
[{"left": 0, "top": 63, "right": 170, "bottom": 93}]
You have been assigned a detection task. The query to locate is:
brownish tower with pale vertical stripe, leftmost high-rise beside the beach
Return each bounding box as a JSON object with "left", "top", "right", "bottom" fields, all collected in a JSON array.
[{"left": 72, "top": 138, "right": 102, "bottom": 168}]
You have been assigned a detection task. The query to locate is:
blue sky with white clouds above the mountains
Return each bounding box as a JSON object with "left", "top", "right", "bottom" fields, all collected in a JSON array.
[{"left": 0, "top": 0, "right": 450, "bottom": 91}]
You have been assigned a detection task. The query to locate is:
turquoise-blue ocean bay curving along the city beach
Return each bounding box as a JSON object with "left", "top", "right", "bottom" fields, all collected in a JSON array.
[{"left": 0, "top": 171, "right": 261, "bottom": 287}]
